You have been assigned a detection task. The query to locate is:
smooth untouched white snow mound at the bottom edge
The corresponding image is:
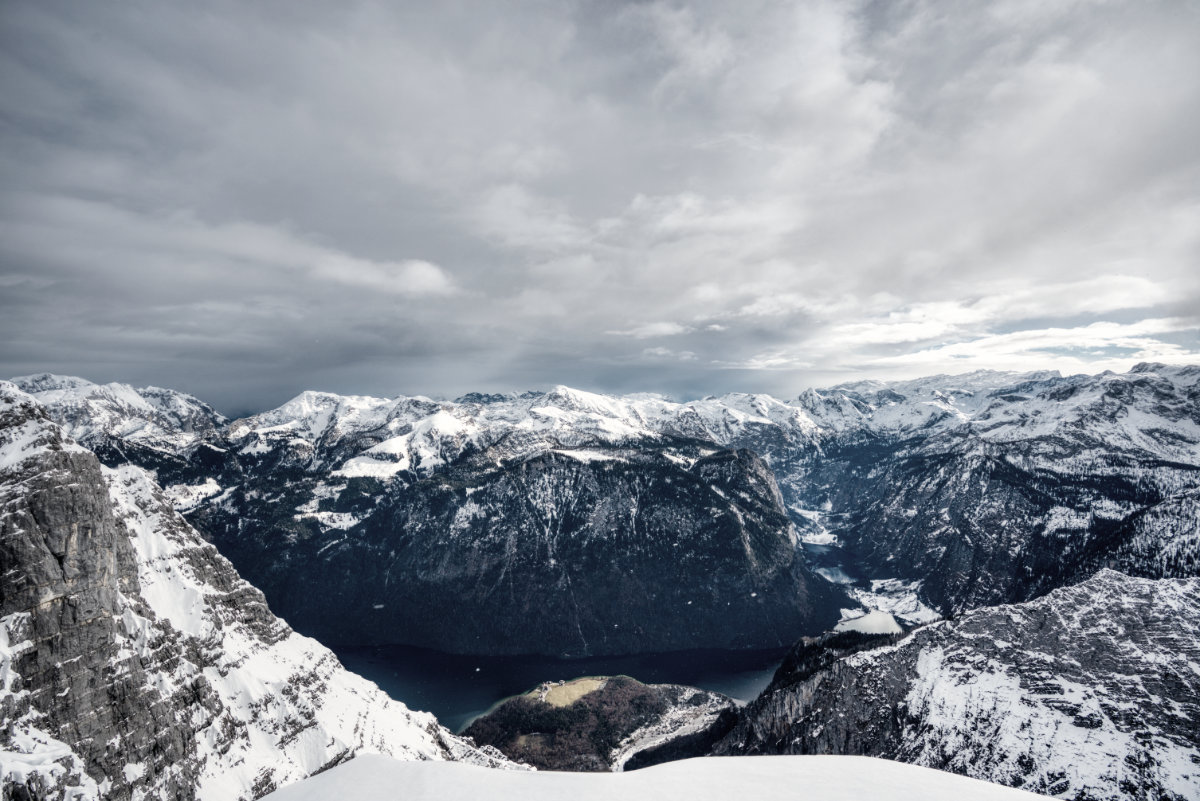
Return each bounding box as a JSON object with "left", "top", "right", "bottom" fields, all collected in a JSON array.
[{"left": 260, "top": 757, "right": 1040, "bottom": 801}]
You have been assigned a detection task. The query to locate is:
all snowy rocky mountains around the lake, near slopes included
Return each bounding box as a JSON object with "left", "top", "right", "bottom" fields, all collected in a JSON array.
[{"left": 0, "top": 365, "right": 1200, "bottom": 801}]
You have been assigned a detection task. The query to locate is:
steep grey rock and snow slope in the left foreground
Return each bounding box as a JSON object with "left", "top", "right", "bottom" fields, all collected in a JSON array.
[{"left": 0, "top": 381, "right": 509, "bottom": 801}]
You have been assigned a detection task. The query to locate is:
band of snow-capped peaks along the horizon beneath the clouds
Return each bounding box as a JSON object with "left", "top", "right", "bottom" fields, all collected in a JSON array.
[{"left": 16, "top": 365, "right": 1200, "bottom": 477}]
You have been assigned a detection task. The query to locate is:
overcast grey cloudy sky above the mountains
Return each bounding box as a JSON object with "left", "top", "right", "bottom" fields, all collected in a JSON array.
[{"left": 0, "top": 0, "right": 1200, "bottom": 412}]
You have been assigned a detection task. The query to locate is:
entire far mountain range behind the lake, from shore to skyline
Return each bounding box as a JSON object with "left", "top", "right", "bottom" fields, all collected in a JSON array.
[{"left": 11, "top": 365, "right": 1200, "bottom": 655}]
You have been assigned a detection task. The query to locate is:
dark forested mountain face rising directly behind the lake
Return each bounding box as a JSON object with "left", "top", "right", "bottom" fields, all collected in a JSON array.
[{"left": 197, "top": 443, "right": 848, "bottom": 656}]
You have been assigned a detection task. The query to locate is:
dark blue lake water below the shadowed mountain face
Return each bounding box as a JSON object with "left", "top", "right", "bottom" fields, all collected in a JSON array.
[{"left": 334, "top": 645, "right": 787, "bottom": 731}]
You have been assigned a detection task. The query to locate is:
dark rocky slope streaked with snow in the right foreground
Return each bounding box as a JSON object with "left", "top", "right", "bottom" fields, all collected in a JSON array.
[{"left": 716, "top": 570, "right": 1200, "bottom": 801}]
